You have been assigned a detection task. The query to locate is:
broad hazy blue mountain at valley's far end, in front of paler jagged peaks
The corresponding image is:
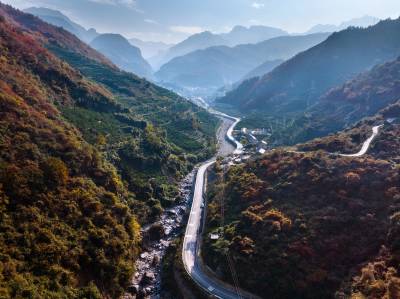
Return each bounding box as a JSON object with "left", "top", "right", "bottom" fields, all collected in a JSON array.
[{"left": 155, "top": 33, "right": 329, "bottom": 88}]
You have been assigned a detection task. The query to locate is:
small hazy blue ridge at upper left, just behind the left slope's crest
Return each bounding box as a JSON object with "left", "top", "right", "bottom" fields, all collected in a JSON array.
[{"left": 24, "top": 7, "right": 99, "bottom": 43}]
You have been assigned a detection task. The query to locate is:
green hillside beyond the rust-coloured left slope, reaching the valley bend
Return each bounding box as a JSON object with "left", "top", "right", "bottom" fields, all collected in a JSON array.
[{"left": 4, "top": 7, "right": 217, "bottom": 219}]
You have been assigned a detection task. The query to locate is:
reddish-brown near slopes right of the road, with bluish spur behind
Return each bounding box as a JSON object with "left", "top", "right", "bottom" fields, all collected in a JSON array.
[{"left": 202, "top": 69, "right": 400, "bottom": 298}]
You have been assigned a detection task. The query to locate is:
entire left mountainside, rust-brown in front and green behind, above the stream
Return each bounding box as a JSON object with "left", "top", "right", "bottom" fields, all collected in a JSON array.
[{"left": 0, "top": 4, "right": 218, "bottom": 298}]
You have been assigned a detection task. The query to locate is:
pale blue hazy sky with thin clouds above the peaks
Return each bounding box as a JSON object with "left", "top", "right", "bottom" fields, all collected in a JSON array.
[{"left": 0, "top": 0, "right": 400, "bottom": 42}]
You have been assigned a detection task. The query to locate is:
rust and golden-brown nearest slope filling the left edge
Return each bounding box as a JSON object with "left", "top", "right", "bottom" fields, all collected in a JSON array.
[{"left": 0, "top": 7, "right": 140, "bottom": 298}]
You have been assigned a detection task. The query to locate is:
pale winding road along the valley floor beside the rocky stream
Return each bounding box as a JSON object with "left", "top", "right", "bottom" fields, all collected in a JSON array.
[{"left": 182, "top": 113, "right": 255, "bottom": 299}]
